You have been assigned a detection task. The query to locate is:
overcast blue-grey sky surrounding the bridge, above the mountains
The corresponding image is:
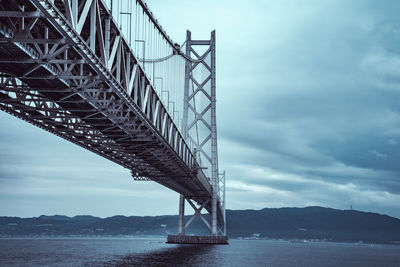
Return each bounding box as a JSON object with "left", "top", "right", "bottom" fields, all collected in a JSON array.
[{"left": 0, "top": 0, "right": 400, "bottom": 217}]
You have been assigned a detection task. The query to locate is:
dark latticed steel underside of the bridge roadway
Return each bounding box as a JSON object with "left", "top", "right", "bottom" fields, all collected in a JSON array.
[{"left": 0, "top": 1, "right": 223, "bottom": 227}]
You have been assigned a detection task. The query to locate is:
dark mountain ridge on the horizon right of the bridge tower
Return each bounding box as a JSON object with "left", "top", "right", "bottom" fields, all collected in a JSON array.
[{"left": 227, "top": 207, "right": 400, "bottom": 243}]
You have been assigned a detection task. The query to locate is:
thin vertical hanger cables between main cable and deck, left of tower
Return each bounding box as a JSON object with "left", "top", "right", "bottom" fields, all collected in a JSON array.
[{"left": 102, "top": 0, "right": 187, "bottom": 138}]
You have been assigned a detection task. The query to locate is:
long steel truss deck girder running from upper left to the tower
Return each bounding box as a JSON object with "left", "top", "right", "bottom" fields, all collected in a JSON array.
[{"left": 0, "top": 0, "right": 216, "bottom": 204}]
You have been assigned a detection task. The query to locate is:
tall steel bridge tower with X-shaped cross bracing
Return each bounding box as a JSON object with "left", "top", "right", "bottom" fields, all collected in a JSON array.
[{"left": 167, "top": 30, "right": 227, "bottom": 244}]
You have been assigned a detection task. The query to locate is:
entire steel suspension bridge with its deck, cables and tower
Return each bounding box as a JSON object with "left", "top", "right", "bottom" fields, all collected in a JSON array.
[{"left": 0, "top": 0, "right": 227, "bottom": 244}]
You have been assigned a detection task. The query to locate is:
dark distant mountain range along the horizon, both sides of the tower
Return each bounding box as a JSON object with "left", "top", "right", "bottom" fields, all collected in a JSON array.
[{"left": 0, "top": 207, "right": 400, "bottom": 243}]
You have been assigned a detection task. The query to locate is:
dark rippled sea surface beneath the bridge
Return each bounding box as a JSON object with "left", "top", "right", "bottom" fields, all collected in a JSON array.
[{"left": 0, "top": 238, "right": 400, "bottom": 267}]
